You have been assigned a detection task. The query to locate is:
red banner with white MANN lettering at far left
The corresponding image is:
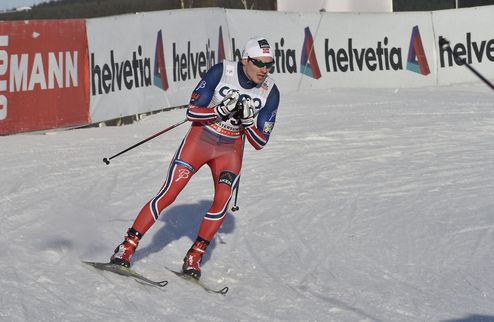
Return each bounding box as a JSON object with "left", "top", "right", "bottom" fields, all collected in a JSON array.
[{"left": 0, "top": 20, "right": 90, "bottom": 135}]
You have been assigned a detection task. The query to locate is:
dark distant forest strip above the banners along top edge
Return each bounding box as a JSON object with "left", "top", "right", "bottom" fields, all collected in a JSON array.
[{"left": 0, "top": 0, "right": 494, "bottom": 21}]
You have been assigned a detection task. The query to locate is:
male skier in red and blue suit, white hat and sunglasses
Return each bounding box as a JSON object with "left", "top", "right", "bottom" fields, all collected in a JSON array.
[{"left": 110, "top": 37, "right": 279, "bottom": 279}]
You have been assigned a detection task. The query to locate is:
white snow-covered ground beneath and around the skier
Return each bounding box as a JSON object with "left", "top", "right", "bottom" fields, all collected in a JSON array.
[{"left": 0, "top": 85, "right": 494, "bottom": 322}]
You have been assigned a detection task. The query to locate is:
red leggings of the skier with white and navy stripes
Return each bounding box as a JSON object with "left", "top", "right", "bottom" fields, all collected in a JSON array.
[{"left": 132, "top": 124, "right": 242, "bottom": 240}]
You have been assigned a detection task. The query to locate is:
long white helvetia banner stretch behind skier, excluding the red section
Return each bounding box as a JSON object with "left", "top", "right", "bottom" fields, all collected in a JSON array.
[{"left": 87, "top": 6, "right": 494, "bottom": 123}]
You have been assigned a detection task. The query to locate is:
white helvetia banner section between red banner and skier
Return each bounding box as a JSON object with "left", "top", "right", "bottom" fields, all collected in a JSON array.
[{"left": 87, "top": 9, "right": 229, "bottom": 122}]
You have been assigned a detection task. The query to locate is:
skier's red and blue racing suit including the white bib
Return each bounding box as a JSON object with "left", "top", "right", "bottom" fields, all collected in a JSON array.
[{"left": 132, "top": 61, "right": 279, "bottom": 241}]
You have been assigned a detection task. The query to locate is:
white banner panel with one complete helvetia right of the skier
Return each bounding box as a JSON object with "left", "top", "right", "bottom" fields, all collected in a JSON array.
[{"left": 303, "top": 12, "right": 436, "bottom": 88}]
